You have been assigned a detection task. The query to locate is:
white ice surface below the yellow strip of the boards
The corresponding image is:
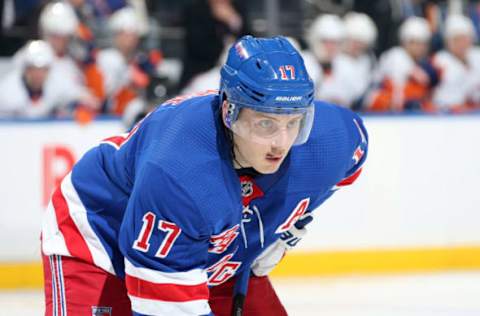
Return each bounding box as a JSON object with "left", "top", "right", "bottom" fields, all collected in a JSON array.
[{"left": 0, "top": 272, "right": 480, "bottom": 316}]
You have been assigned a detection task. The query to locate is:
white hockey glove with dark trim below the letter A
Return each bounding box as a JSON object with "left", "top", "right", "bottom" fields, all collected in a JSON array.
[{"left": 251, "top": 213, "right": 313, "bottom": 276}]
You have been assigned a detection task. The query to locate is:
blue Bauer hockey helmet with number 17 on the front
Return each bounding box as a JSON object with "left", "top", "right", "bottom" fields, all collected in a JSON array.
[{"left": 220, "top": 36, "right": 314, "bottom": 145}]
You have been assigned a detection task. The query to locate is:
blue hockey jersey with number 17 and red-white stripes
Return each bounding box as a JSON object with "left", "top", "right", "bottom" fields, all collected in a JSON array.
[{"left": 42, "top": 90, "right": 367, "bottom": 315}]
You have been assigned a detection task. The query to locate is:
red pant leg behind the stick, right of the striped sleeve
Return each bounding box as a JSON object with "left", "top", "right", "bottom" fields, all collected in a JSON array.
[{"left": 209, "top": 276, "right": 287, "bottom": 316}]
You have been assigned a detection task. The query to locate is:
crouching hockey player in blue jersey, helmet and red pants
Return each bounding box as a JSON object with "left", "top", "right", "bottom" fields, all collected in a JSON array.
[{"left": 42, "top": 36, "right": 367, "bottom": 316}]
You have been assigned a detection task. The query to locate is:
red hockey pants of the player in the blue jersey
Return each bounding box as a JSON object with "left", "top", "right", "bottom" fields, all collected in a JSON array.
[{"left": 42, "top": 256, "right": 287, "bottom": 316}]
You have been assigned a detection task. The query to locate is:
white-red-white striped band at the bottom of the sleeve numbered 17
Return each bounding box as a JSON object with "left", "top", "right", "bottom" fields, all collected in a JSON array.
[{"left": 125, "top": 259, "right": 210, "bottom": 316}]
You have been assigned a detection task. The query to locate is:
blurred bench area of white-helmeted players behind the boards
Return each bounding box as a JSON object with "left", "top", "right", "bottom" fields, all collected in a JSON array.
[{"left": 0, "top": 0, "right": 480, "bottom": 125}]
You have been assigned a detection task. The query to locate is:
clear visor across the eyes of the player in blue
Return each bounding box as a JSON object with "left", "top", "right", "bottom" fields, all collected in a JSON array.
[{"left": 230, "top": 105, "right": 314, "bottom": 146}]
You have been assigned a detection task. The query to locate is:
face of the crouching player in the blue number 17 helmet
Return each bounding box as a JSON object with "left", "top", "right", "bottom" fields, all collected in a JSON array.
[{"left": 233, "top": 108, "right": 303, "bottom": 174}]
